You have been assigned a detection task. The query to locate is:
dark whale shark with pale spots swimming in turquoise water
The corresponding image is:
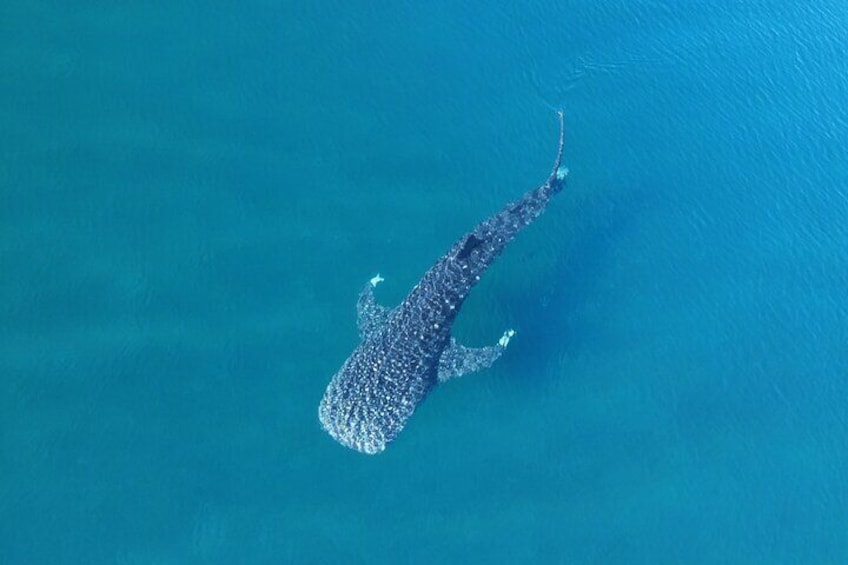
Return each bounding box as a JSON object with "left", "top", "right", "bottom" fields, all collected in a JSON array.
[{"left": 318, "top": 111, "right": 568, "bottom": 455}]
